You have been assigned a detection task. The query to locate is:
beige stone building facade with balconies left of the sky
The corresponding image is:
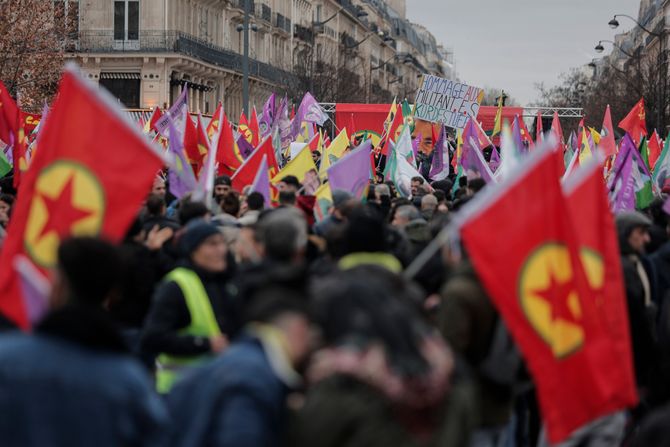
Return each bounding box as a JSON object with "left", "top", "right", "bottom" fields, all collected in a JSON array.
[{"left": 72, "top": 0, "right": 456, "bottom": 116}]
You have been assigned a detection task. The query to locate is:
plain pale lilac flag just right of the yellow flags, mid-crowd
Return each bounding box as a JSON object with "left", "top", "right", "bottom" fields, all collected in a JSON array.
[{"left": 328, "top": 140, "right": 372, "bottom": 200}]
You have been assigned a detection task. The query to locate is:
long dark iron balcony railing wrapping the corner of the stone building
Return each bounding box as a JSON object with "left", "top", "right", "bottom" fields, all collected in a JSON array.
[{"left": 78, "top": 30, "right": 293, "bottom": 84}]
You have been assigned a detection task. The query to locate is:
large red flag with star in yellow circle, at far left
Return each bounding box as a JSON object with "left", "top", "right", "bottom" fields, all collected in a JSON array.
[{"left": 0, "top": 68, "right": 163, "bottom": 328}]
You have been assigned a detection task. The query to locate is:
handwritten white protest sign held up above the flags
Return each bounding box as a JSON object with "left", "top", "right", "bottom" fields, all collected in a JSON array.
[{"left": 414, "top": 75, "right": 484, "bottom": 129}]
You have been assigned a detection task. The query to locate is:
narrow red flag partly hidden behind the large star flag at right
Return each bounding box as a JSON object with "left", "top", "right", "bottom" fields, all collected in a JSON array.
[{"left": 563, "top": 158, "right": 638, "bottom": 411}]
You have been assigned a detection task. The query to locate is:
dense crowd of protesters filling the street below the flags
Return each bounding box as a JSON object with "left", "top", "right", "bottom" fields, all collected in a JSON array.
[{"left": 0, "top": 156, "right": 670, "bottom": 447}]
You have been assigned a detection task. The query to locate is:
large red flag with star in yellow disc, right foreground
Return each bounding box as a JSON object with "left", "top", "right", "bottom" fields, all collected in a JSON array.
[{"left": 459, "top": 144, "right": 621, "bottom": 443}]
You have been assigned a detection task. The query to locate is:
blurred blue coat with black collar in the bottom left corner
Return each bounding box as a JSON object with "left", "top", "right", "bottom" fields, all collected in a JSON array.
[{"left": 0, "top": 306, "right": 168, "bottom": 447}]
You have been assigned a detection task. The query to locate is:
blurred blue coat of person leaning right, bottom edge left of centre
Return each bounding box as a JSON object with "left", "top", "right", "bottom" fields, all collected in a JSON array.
[{"left": 168, "top": 336, "right": 289, "bottom": 447}]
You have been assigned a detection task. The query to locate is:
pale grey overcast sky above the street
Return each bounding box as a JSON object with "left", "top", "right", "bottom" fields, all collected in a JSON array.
[{"left": 407, "top": 0, "right": 640, "bottom": 105}]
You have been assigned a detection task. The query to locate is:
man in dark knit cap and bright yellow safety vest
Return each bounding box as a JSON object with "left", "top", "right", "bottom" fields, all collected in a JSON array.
[{"left": 142, "top": 220, "right": 237, "bottom": 393}]
